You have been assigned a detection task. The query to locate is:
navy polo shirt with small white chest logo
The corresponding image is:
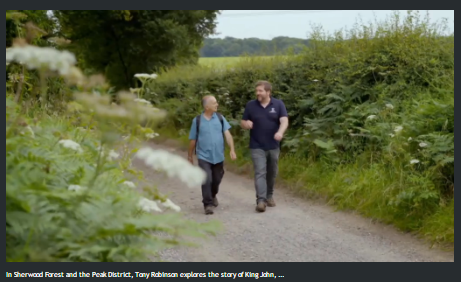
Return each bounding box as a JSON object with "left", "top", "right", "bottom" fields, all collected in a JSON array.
[{"left": 242, "top": 97, "right": 288, "bottom": 151}]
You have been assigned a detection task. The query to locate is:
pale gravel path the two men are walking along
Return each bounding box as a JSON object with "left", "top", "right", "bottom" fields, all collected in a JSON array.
[{"left": 134, "top": 144, "right": 454, "bottom": 262}]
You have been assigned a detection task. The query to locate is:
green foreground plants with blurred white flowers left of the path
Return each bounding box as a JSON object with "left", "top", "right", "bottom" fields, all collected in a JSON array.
[{"left": 6, "top": 40, "right": 217, "bottom": 262}]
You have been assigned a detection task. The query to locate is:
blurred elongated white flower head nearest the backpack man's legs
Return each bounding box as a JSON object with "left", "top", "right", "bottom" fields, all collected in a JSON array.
[{"left": 136, "top": 147, "right": 206, "bottom": 188}]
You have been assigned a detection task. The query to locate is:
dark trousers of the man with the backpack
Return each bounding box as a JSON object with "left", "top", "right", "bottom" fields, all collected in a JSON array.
[{"left": 198, "top": 159, "right": 224, "bottom": 207}]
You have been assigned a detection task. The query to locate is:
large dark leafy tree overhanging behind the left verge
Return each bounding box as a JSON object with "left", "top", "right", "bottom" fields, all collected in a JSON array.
[{"left": 54, "top": 10, "right": 219, "bottom": 89}]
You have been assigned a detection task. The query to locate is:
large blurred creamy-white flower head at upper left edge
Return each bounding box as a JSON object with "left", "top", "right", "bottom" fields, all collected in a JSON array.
[{"left": 6, "top": 45, "right": 77, "bottom": 75}]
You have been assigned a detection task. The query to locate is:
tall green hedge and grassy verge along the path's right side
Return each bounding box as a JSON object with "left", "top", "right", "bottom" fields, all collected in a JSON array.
[{"left": 143, "top": 12, "right": 454, "bottom": 247}]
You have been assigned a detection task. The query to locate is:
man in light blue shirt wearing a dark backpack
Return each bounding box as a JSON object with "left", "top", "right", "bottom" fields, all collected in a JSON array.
[{"left": 188, "top": 95, "right": 236, "bottom": 214}]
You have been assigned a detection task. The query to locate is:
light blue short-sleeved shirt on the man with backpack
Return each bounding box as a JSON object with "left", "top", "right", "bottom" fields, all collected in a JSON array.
[{"left": 189, "top": 113, "right": 231, "bottom": 164}]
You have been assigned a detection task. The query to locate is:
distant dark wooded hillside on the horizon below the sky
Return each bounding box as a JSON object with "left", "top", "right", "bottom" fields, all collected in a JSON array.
[{"left": 200, "top": 36, "right": 309, "bottom": 57}]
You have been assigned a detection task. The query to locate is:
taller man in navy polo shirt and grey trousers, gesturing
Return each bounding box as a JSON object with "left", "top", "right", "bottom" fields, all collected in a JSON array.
[{"left": 241, "top": 81, "right": 288, "bottom": 212}]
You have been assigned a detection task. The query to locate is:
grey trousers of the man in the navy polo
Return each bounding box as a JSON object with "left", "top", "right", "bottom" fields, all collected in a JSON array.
[{"left": 250, "top": 149, "right": 280, "bottom": 203}]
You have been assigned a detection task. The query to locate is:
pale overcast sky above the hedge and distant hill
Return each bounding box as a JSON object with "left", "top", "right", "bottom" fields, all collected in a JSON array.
[{"left": 212, "top": 10, "right": 455, "bottom": 39}]
